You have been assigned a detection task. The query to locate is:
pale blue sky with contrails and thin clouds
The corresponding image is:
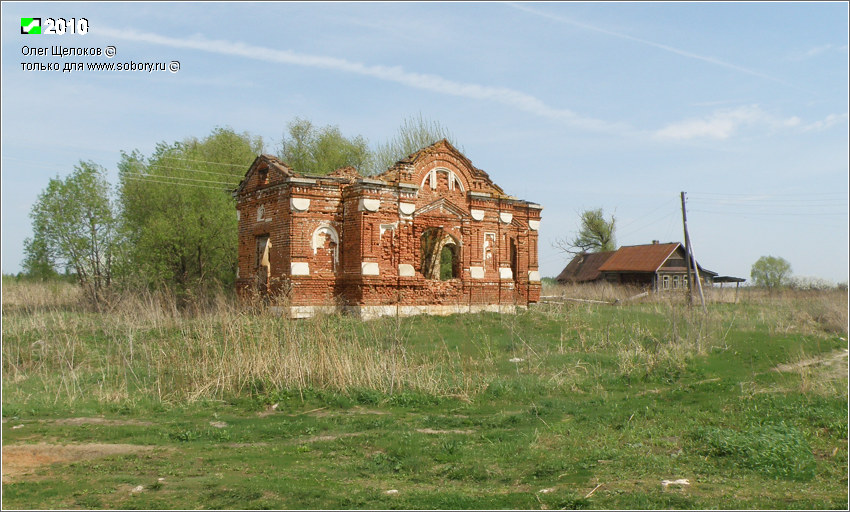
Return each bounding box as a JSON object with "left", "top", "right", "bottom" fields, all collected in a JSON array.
[{"left": 0, "top": 2, "right": 850, "bottom": 283}]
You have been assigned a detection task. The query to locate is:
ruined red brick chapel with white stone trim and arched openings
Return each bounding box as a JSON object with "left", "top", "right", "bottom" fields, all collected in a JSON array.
[{"left": 235, "top": 140, "right": 542, "bottom": 318}]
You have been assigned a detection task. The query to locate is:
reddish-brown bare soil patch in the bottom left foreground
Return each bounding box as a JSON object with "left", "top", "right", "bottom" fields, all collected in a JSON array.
[{"left": 3, "top": 443, "right": 159, "bottom": 483}]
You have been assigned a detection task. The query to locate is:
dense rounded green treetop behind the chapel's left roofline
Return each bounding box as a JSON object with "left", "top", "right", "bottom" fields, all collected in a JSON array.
[{"left": 278, "top": 118, "right": 372, "bottom": 175}]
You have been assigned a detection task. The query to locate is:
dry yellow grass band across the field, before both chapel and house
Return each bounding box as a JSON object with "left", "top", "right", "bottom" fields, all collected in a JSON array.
[{"left": 3, "top": 282, "right": 847, "bottom": 404}]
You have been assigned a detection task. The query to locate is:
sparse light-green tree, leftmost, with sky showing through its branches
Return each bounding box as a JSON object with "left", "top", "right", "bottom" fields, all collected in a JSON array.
[{"left": 24, "top": 161, "right": 118, "bottom": 306}]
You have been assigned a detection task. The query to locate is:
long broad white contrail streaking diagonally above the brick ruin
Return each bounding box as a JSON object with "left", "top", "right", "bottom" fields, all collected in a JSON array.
[{"left": 99, "top": 28, "right": 631, "bottom": 133}]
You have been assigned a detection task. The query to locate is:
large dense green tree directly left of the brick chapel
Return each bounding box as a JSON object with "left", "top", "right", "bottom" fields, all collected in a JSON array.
[{"left": 118, "top": 128, "right": 263, "bottom": 298}]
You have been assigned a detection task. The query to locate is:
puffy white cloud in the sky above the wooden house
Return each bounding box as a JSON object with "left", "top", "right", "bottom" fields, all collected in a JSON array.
[{"left": 655, "top": 105, "right": 801, "bottom": 140}]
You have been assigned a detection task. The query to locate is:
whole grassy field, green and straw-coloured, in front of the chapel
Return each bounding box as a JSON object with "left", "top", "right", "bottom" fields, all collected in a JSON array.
[{"left": 2, "top": 281, "right": 848, "bottom": 509}]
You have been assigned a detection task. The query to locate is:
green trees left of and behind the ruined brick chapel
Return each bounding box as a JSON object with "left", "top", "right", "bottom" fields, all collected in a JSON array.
[{"left": 22, "top": 114, "right": 457, "bottom": 308}]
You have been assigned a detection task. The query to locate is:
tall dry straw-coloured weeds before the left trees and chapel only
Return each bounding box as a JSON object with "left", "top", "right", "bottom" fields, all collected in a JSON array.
[{"left": 3, "top": 285, "right": 487, "bottom": 402}]
